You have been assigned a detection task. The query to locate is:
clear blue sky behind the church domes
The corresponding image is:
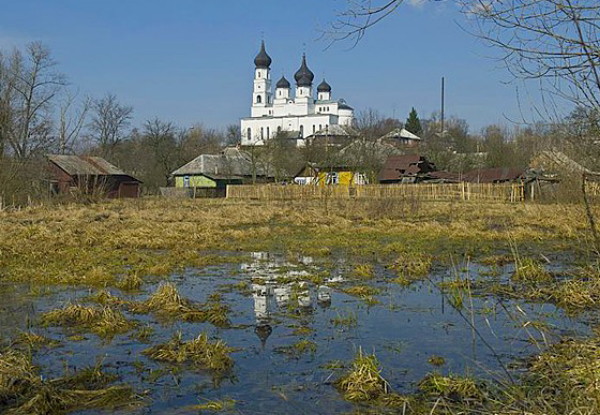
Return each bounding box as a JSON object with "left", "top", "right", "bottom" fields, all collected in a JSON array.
[{"left": 0, "top": 0, "right": 556, "bottom": 132}]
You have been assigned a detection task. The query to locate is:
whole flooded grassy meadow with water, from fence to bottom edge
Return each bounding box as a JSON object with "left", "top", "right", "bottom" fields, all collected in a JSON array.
[{"left": 0, "top": 199, "right": 600, "bottom": 415}]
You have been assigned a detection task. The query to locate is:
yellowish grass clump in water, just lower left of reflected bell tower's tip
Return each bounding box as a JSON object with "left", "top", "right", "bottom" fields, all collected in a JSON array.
[{"left": 142, "top": 332, "right": 233, "bottom": 373}]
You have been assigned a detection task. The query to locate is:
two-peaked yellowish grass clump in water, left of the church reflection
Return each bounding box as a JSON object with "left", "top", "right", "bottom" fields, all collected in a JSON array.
[{"left": 130, "top": 282, "right": 230, "bottom": 327}]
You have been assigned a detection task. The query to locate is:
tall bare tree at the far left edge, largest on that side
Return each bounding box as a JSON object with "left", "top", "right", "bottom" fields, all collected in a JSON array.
[{"left": 0, "top": 42, "right": 66, "bottom": 160}]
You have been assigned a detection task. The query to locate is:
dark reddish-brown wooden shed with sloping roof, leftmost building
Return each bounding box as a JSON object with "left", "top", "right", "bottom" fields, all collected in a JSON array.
[{"left": 47, "top": 155, "right": 142, "bottom": 198}]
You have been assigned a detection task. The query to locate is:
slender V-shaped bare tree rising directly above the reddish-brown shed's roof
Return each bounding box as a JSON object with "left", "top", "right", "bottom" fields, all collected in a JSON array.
[{"left": 58, "top": 91, "right": 92, "bottom": 154}]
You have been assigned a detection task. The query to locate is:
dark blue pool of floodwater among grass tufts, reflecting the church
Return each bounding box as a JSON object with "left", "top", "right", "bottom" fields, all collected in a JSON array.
[{"left": 0, "top": 253, "right": 589, "bottom": 414}]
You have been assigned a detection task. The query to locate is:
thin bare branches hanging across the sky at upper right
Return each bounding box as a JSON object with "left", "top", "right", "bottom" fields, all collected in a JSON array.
[{"left": 327, "top": 0, "right": 600, "bottom": 109}]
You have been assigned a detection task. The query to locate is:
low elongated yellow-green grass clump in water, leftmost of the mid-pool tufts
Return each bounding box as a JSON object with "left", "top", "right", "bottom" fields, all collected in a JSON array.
[{"left": 41, "top": 304, "right": 136, "bottom": 339}]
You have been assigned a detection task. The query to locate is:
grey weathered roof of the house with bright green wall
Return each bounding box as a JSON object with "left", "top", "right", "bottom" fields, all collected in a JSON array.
[{"left": 171, "top": 148, "right": 274, "bottom": 178}]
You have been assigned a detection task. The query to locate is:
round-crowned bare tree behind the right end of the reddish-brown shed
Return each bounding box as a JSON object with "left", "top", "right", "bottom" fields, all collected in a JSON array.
[{"left": 88, "top": 94, "right": 133, "bottom": 157}]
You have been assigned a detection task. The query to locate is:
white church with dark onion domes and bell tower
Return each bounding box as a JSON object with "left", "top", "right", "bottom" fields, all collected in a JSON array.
[{"left": 241, "top": 41, "right": 354, "bottom": 146}]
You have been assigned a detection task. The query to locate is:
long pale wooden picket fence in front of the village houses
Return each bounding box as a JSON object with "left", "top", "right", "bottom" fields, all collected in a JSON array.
[{"left": 227, "top": 183, "right": 525, "bottom": 202}]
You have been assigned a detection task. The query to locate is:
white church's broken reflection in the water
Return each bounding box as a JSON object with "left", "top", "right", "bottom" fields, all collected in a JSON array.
[{"left": 241, "top": 252, "right": 331, "bottom": 346}]
